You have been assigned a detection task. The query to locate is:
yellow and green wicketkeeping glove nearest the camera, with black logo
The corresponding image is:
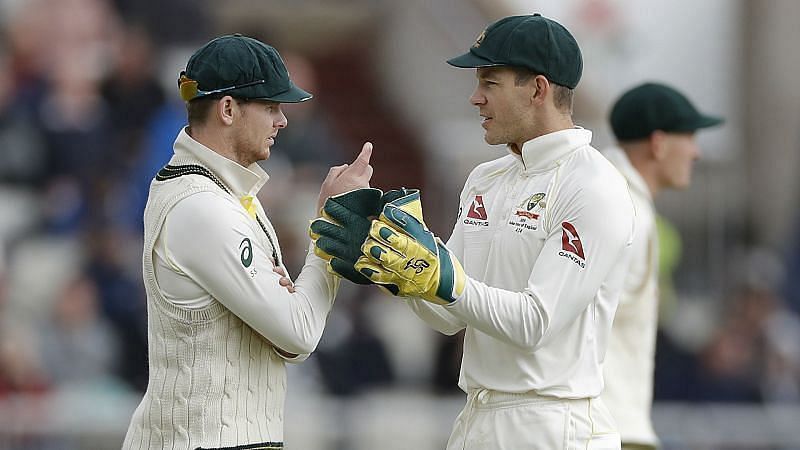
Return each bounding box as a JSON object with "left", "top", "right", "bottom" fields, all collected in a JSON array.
[{"left": 355, "top": 191, "right": 466, "bottom": 305}]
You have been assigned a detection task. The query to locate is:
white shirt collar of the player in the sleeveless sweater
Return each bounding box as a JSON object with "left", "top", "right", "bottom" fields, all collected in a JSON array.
[{"left": 173, "top": 127, "right": 269, "bottom": 197}]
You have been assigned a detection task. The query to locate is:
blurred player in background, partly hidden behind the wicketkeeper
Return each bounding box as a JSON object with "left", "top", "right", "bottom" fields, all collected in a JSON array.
[{"left": 602, "top": 83, "right": 722, "bottom": 450}]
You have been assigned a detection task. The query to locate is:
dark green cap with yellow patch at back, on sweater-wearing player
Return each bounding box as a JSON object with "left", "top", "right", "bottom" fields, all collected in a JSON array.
[{"left": 178, "top": 33, "right": 312, "bottom": 103}]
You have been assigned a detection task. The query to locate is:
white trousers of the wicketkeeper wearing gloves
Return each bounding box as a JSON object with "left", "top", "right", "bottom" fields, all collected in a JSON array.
[{"left": 447, "top": 389, "right": 620, "bottom": 450}]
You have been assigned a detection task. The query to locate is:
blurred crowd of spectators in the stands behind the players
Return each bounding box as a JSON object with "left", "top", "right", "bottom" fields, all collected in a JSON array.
[{"left": 0, "top": 0, "right": 800, "bottom": 450}]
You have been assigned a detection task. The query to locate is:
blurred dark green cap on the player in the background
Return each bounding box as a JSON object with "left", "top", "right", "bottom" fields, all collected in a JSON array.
[{"left": 609, "top": 83, "right": 725, "bottom": 141}]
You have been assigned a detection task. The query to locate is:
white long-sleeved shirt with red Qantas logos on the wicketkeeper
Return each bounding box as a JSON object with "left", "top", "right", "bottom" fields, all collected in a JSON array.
[{"left": 409, "top": 128, "right": 634, "bottom": 398}]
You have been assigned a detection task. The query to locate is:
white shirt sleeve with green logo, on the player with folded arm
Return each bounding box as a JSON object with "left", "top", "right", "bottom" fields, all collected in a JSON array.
[{"left": 165, "top": 192, "right": 338, "bottom": 361}]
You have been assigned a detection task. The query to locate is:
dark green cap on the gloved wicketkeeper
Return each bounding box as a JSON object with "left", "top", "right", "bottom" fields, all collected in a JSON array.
[{"left": 447, "top": 13, "right": 583, "bottom": 89}]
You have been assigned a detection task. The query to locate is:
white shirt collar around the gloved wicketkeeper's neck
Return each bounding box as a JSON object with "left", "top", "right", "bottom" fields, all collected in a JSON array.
[{"left": 509, "top": 127, "right": 592, "bottom": 172}]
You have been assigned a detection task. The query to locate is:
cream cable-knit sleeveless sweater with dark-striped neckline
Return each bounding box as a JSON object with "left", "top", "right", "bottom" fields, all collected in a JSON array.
[{"left": 123, "top": 158, "right": 286, "bottom": 449}]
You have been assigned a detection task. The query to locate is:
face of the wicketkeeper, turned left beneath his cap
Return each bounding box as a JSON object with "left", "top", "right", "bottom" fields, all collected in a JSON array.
[{"left": 469, "top": 67, "right": 535, "bottom": 145}]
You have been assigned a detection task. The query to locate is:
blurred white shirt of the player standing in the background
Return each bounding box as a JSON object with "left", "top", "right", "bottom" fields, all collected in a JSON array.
[{"left": 602, "top": 148, "right": 658, "bottom": 446}]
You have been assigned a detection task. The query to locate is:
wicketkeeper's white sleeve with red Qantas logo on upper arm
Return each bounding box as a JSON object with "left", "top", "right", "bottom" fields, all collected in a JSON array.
[{"left": 446, "top": 178, "right": 633, "bottom": 351}]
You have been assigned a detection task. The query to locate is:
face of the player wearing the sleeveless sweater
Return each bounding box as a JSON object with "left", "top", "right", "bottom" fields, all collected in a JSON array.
[{"left": 236, "top": 100, "right": 288, "bottom": 167}]
